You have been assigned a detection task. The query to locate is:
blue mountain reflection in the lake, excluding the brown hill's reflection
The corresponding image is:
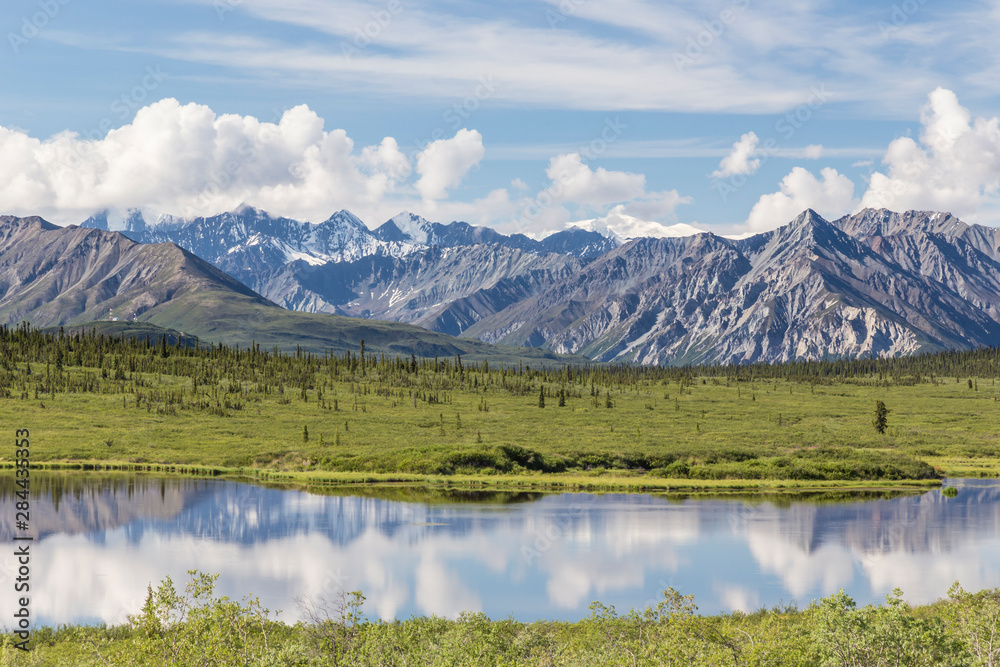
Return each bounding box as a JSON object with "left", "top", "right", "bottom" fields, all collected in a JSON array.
[{"left": 127, "top": 482, "right": 1000, "bottom": 555}]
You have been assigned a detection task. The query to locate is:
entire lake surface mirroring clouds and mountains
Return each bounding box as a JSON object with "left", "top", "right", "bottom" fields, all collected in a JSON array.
[{"left": 0, "top": 478, "right": 1000, "bottom": 626}]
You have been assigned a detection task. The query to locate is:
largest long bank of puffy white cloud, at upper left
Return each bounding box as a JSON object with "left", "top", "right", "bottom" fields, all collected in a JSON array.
[{"left": 0, "top": 99, "right": 412, "bottom": 223}]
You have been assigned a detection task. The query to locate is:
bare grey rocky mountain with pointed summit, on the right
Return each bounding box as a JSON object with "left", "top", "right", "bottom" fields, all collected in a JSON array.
[{"left": 464, "top": 210, "right": 1000, "bottom": 364}]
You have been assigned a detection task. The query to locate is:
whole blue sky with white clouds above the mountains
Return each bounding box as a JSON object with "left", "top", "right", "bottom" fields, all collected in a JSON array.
[{"left": 0, "top": 0, "right": 1000, "bottom": 236}]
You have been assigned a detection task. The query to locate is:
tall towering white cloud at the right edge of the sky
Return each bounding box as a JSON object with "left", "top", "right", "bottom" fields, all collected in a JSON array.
[{"left": 861, "top": 88, "right": 1000, "bottom": 220}]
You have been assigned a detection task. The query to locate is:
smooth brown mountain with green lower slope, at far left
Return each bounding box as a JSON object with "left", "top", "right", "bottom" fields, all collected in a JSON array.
[{"left": 0, "top": 216, "right": 585, "bottom": 363}]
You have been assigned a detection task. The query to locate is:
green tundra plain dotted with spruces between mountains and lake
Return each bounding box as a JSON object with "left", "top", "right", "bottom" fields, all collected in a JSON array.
[{"left": 0, "top": 326, "right": 1000, "bottom": 489}]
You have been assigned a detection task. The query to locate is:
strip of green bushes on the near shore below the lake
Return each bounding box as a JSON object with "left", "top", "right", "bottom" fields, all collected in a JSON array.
[{"left": 0, "top": 572, "right": 1000, "bottom": 667}]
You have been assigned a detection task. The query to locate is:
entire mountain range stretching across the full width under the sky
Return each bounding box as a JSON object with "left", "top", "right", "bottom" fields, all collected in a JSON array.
[{"left": 0, "top": 206, "right": 1000, "bottom": 364}]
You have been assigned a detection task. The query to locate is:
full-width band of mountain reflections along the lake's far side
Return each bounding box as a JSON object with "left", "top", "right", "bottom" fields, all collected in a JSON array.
[{"left": 0, "top": 474, "right": 1000, "bottom": 555}]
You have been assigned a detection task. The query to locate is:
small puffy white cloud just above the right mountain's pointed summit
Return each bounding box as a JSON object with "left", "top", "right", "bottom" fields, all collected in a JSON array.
[{"left": 746, "top": 167, "right": 856, "bottom": 232}]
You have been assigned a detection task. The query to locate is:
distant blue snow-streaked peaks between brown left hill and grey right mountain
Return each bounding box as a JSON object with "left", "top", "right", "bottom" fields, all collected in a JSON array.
[{"left": 82, "top": 206, "right": 620, "bottom": 335}]
